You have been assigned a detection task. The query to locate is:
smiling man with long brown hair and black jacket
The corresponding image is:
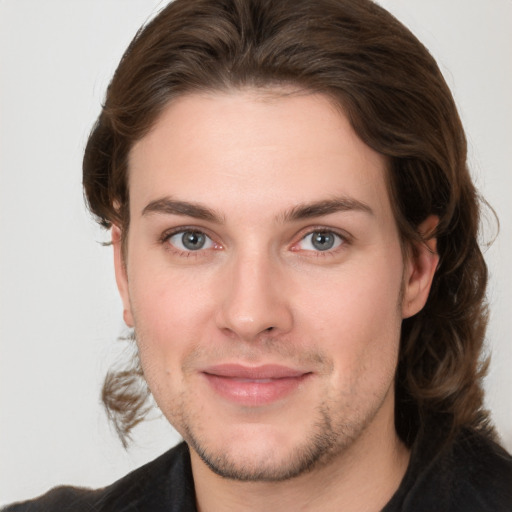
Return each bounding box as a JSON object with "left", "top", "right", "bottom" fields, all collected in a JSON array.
[{"left": 4, "top": 0, "right": 512, "bottom": 511}]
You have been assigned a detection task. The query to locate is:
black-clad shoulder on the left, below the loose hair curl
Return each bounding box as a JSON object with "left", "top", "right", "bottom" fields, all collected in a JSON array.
[{"left": 2, "top": 443, "right": 195, "bottom": 512}]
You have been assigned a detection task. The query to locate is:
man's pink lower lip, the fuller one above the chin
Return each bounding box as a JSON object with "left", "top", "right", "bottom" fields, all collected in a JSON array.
[{"left": 203, "top": 373, "right": 309, "bottom": 407}]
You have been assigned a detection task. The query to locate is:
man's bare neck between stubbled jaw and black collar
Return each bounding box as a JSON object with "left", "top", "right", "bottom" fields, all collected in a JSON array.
[{"left": 191, "top": 406, "right": 410, "bottom": 512}]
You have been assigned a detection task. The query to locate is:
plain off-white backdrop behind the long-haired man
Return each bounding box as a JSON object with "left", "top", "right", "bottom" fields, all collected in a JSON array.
[{"left": 0, "top": 0, "right": 512, "bottom": 504}]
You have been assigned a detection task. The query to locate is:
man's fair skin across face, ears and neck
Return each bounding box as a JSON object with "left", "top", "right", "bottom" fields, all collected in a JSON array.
[{"left": 112, "top": 89, "right": 437, "bottom": 512}]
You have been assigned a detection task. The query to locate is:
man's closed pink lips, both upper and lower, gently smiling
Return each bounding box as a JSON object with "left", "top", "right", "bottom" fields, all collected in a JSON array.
[{"left": 202, "top": 364, "right": 311, "bottom": 407}]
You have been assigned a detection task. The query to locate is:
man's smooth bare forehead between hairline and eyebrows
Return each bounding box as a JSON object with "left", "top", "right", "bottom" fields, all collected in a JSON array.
[{"left": 129, "top": 90, "right": 389, "bottom": 220}]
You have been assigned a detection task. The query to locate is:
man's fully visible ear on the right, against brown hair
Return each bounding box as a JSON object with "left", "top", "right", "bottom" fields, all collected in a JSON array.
[{"left": 402, "top": 215, "right": 439, "bottom": 318}]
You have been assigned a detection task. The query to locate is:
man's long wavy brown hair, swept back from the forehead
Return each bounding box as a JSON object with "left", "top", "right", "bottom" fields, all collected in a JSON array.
[{"left": 83, "top": 0, "right": 491, "bottom": 445}]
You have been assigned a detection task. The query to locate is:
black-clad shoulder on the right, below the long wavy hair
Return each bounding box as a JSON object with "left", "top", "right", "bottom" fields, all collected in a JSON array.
[{"left": 385, "top": 430, "right": 512, "bottom": 512}]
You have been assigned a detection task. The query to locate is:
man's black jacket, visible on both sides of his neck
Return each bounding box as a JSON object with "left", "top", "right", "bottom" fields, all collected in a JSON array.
[{"left": 3, "top": 431, "right": 512, "bottom": 512}]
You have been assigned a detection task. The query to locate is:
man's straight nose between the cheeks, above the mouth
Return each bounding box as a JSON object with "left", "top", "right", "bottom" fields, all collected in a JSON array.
[{"left": 217, "top": 247, "right": 293, "bottom": 341}]
